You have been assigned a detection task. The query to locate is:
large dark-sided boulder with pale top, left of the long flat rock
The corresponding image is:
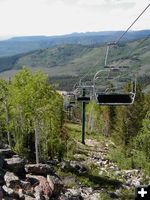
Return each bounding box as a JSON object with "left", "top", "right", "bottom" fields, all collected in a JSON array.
[{"left": 5, "top": 156, "right": 25, "bottom": 175}]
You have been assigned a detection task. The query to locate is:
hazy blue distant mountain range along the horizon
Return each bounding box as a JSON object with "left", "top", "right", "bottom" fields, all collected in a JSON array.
[{"left": 0, "top": 30, "right": 150, "bottom": 57}]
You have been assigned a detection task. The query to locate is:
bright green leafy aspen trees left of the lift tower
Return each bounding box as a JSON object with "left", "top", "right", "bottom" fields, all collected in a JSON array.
[{"left": 0, "top": 68, "right": 65, "bottom": 162}]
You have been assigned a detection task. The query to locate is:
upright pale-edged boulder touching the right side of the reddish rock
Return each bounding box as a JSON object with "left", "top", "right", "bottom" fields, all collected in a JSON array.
[{"left": 47, "top": 175, "right": 63, "bottom": 196}]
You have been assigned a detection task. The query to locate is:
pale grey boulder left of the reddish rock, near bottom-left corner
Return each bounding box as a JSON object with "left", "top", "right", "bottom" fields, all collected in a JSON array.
[{"left": 4, "top": 172, "right": 20, "bottom": 189}]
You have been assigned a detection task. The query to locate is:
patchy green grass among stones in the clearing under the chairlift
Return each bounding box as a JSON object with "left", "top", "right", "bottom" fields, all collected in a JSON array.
[{"left": 59, "top": 123, "right": 150, "bottom": 200}]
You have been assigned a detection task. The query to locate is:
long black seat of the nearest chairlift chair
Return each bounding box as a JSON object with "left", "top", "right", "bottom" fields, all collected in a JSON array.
[{"left": 97, "top": 93, "right": 135, "bottom": 105}]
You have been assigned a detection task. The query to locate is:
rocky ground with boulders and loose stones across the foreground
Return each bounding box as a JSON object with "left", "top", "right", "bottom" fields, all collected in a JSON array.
[{"left": 0, "top": 139, "right": 150, "bottom": 200}]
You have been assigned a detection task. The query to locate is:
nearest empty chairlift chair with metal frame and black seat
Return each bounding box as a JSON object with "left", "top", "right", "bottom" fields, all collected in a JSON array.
[{"left": 93, "top": 69, "right": 136, "bottom": 105}]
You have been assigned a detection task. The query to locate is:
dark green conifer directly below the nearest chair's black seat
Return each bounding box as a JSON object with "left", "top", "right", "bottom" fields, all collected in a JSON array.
[{"left": 113, "top": 85, "right": 145, "bottom": 146}]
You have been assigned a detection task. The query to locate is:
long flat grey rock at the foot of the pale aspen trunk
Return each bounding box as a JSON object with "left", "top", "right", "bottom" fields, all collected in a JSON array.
[{"left": 25, "top": 163, "right": 54, "bottom": 175}]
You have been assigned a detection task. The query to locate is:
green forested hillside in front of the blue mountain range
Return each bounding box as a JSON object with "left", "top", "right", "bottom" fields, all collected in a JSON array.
[{"left": 0, "top": 38, "right": 150, "bottom": 91}]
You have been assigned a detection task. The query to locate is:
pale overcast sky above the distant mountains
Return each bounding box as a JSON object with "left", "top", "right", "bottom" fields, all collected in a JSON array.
[{"left": 0, "top": 0, "right": 150, "bottom": 38}]
